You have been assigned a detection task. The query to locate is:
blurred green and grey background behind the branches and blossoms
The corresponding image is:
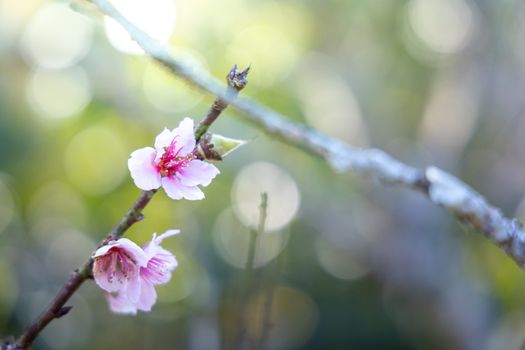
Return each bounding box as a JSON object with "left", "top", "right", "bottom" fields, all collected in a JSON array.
[{"left": 0, "top": 0, "right": 525, "bottom": 350}]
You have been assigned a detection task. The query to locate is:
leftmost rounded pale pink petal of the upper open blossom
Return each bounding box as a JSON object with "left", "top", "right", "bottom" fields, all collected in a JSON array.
[{"left": 128, "top": 147, "right": 160, "bottom": 191}]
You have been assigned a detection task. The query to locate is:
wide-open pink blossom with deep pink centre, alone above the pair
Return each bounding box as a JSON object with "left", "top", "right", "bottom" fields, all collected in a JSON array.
[{"left": 128, "top": 118, "right": 219, "bottom": 200}]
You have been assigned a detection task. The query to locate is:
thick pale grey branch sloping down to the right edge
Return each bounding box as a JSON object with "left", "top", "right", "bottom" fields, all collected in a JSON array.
[{"left": 92, "top": 0, "right": 525, "bottom": 268}]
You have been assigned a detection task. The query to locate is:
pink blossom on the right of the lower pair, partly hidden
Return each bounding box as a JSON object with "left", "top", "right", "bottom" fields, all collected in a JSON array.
[{"left": 107, "top": 230, "right": 180, "bottom": 314}]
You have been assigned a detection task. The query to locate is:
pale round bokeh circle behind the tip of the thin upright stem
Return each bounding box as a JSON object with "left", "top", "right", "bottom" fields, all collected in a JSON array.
[{"left": 232, "top": 162, "right": 301, "bottom": 231}]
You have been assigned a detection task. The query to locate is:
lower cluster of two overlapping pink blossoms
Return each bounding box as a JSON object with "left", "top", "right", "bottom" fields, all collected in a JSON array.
[{"left": 93, "top": 230, "right": 180, "bottom": 315}]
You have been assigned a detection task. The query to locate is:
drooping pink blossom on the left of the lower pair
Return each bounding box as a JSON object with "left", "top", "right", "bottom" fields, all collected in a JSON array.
[{"left": 93, "top": 238, "right": 148, "bottom": 301}]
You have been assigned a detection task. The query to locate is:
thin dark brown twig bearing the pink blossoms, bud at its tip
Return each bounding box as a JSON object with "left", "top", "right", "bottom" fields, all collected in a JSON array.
[{"left": 5, "top": 66, "right": 249, "bottom": 350}]
